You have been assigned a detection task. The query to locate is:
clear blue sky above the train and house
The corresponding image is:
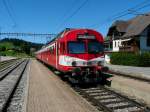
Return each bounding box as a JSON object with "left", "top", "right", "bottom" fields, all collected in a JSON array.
[{"left": 0, "top": 0, "right": 150, "bottom": 42}]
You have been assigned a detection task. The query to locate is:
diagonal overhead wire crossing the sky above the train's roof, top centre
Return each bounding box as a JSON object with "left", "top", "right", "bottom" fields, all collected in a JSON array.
[{"left": 56, "top": 0, "right": 89, "bottom": 29}]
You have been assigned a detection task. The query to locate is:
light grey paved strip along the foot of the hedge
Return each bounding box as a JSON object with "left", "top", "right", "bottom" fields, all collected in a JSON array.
[{"left": 105, "top": 63, "right": 150, "bottom": 81}]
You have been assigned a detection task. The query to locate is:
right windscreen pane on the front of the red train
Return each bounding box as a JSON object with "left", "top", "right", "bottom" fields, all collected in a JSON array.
[{"left": 88, "top": 41, "right": 104, "bottom": 53}]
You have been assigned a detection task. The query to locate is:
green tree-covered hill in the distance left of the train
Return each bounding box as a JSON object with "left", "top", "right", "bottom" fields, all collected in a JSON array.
[{"left": 0, "top": 38, "right": 43, "bottom": 57}]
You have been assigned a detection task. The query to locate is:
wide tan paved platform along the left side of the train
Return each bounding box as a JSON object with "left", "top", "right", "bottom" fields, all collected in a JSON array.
[{"left": 27, "top": 60, "right": 98, "bottom": 112}]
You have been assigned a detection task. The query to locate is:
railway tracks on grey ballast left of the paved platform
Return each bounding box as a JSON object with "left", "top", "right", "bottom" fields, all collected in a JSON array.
[{"left": 0, "top": 59, "right": 29, "bottom": 112}]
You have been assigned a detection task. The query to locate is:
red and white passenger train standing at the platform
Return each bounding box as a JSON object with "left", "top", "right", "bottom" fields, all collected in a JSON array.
[{"left": 36, "top": 28, "right": 110, "bottom": 84}]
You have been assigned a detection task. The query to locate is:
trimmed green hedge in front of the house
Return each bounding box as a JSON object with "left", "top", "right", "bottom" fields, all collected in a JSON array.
[{"left": 111, "top": 52, "right": 150, "bottom": 67}]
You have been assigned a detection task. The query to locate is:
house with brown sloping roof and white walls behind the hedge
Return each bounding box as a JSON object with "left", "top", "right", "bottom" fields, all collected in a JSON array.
[{"left": 107, "top": 14, "right": 150, "bottom": 52}]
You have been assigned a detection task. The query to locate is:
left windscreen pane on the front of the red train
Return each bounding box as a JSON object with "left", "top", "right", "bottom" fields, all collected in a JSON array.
[{"left": 68, "top": 42, "right": 86, "bottom": 54}]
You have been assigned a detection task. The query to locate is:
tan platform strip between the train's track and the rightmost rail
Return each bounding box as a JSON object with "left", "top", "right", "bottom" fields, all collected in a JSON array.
[{"left": 111, "top": 76, "right": 150, "bottom": 107}]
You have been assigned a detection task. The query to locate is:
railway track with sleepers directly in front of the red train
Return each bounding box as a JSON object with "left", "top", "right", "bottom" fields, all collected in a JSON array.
[{"left": 74, "top": 86, "right": 150, "bottom": 112}]
